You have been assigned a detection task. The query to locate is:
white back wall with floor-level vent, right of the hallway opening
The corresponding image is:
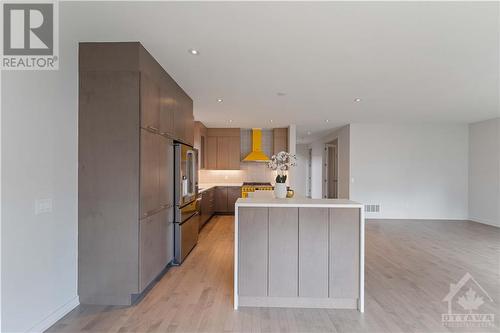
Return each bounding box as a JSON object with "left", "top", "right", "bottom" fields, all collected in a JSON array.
[{"left": 350, "top": 124, "right": 468, "bottom": 219}]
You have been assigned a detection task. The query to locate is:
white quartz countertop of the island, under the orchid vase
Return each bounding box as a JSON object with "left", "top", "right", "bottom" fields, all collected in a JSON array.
[{"left": 236, "top": 197, "right": 363, "bottom": 208}]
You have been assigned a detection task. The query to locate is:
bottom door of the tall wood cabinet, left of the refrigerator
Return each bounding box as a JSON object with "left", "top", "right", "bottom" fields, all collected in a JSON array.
[{"left": 139, "top": 209, "right": 168, "bottom": 291}]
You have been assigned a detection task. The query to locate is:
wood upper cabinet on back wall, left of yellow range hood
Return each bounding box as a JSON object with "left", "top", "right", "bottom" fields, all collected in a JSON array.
[{"left": 206, "top": 128, "right": 241, "bottom": 170}]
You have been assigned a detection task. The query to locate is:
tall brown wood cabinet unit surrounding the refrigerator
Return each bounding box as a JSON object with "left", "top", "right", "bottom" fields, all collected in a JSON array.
[{"left": 78, "top": 43, "right": 194, "bottom": 305}]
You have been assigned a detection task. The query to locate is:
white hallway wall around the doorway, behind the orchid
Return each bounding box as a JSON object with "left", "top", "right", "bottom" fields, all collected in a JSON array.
[{"left": 310, "top": 125, "right": 351, "bottom": 199}]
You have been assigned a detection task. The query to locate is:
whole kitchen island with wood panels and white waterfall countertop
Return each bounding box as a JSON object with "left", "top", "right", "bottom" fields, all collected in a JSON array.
[{"left": 234, "top": 198, "right": 365, "bottom": 312}]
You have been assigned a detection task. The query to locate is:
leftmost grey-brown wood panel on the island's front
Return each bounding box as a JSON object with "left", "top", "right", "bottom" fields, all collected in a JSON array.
[{"left": 237, "top": 207, "right": 269, "bottom": 297}]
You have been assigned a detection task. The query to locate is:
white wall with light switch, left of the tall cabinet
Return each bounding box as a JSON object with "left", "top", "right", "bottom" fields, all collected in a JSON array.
[{"left": 0, "top": 18, "right": 78, "bottom": 332}]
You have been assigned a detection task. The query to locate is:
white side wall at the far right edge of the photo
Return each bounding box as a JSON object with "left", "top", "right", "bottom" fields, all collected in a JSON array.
[{"left": 469, "top": 118, "right": 500, "bottom": 226}]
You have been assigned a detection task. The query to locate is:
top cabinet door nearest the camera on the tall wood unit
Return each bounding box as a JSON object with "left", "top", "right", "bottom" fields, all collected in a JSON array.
[{"left": 141, "top": 73, "right": 160, "bottom": 132}]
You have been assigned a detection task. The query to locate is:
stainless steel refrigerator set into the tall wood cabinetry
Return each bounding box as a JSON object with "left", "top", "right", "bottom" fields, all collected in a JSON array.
[{"left": 174, "top": 143, "right": 200, "bottom": 264}]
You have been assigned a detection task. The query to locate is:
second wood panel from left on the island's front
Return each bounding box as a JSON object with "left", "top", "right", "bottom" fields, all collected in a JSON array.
[{"left": 269, "top": 207, "right": 299, "bottom": 297}]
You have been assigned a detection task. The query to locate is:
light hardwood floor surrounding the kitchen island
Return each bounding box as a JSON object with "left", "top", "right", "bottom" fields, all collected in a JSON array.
[{"left": 48, "top": 216, "right": 500, "bottom": 333}]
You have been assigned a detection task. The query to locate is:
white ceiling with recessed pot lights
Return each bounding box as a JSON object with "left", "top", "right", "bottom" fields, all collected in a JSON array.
[{"left": 60, "top": 2, "right": 500, "bottom": 140}]
